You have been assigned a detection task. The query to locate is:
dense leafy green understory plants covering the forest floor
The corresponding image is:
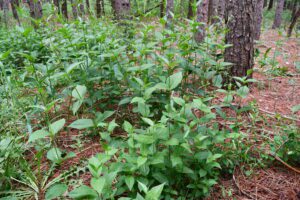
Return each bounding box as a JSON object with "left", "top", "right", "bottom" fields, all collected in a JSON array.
[{"left": 0, "top": 1, "right": 300, "bottom": 200}]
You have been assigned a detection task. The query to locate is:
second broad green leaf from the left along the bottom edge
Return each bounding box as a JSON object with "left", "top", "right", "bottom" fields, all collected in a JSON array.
[{"left": 69, "top": 185, "right": 98, "bottom": 200}]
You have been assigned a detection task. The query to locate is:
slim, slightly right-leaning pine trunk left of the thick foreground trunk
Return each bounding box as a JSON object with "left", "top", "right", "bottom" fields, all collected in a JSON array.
[{"left": 195, "top": 0, "right": 209, "bottom": 42}]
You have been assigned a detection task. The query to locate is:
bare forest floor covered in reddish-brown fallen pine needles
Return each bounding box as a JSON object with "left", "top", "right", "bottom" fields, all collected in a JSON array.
[{"left": 45, "top": 31, "right": 300, "bottom": 200}]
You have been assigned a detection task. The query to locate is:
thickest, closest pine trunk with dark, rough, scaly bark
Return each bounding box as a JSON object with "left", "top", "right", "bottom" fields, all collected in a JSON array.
[{"left": 224, "top": 0, "right": 255, "bottom": 77}]
